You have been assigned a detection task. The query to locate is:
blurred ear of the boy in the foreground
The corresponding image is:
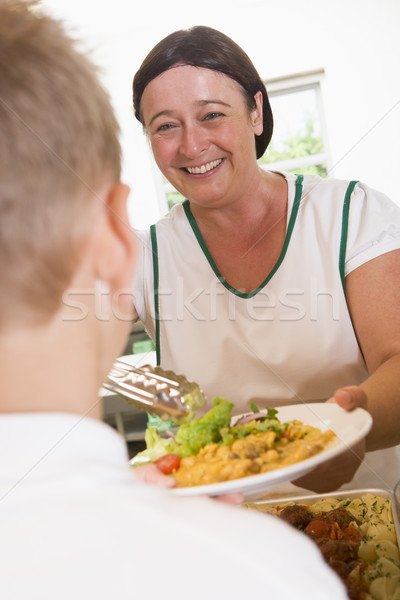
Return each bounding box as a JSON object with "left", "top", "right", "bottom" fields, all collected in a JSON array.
[{"left": 94, "top": 182, "right": 136, "bottom": 291}]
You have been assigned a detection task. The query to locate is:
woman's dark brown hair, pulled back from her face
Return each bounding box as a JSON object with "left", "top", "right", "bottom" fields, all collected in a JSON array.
[{"left": 133, "top": 25, "right": 273, "bottom": 158}]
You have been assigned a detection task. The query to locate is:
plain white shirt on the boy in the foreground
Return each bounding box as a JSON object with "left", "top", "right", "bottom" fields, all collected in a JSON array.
[{"left": 0, "top": 413, "right": 347, "bottom": 600}]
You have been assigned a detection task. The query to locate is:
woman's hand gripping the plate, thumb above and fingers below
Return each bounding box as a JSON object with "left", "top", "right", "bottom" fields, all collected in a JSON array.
[{"left": 293, "top": 385, "right": 367, "bottom": 494}]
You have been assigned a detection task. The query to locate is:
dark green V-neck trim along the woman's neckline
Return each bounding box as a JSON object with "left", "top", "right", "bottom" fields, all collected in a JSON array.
[{"left": 182, "top": 175, "right": 304, "bottom": 298}]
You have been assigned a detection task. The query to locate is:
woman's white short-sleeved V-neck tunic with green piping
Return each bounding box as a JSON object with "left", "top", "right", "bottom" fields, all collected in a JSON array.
[{"left": 135, "top": 174, "right": 400, "bottom": 487}]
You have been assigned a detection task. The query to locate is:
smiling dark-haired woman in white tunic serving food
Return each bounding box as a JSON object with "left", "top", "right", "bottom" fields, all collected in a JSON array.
[{"left": 133, "top": 27, "right": 400, "bottom": 487}]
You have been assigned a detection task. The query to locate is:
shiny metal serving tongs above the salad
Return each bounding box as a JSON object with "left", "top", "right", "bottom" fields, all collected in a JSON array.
[{"left": 103, "top": 360, "right": 198, "bottom": 421}]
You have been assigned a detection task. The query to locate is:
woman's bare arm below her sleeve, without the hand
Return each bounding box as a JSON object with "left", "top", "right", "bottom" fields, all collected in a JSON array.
[{"left": 344, "top": 250, "right": 400, "bottom": 450}]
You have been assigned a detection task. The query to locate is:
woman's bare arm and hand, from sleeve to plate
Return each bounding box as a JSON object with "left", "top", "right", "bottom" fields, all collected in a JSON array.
[{"left": 293, "top": 250, "right": 400, "bottom": 493}]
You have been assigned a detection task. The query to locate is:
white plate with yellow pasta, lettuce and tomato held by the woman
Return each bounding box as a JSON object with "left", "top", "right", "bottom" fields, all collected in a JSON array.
[{"left": 131, "top": 398, "right": 372, "bottom": 499}]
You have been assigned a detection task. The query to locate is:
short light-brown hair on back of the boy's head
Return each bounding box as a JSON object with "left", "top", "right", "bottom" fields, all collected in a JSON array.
[{"left": 0, "top": 0, "right": 120, "bottom": 331}]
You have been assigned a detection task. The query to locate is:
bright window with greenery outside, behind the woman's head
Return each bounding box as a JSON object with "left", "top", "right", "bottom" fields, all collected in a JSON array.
[{"left": 155, "top": 71, "right": 329, "bottom": 212}]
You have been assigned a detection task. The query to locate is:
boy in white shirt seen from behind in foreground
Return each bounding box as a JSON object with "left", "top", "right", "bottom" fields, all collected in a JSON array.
[{"left": 0, "top": 0, "right": 346, "bottom": 600}]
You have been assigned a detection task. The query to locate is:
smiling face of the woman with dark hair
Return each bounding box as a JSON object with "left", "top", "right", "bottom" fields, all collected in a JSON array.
[{"left": 141, "top": 65, "right": 262, "bottom": 207}]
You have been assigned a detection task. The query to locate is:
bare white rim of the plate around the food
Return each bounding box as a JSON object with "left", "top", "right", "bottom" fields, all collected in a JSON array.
[{"left": 170, "top": 402, "right": 372, "bottom": 500}]
